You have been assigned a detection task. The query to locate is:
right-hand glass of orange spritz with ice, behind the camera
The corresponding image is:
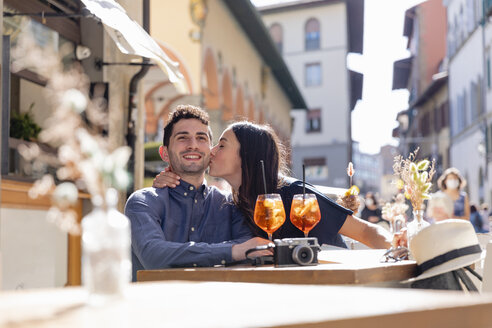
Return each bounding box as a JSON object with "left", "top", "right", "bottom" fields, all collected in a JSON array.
[{"left": 290, "top": 194, "right": 321, "bottom": 237}]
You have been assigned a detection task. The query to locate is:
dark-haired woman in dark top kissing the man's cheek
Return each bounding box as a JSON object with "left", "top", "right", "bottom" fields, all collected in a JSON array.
[{"left": 154, "top": 122, "right": 391, "bottom": 248}]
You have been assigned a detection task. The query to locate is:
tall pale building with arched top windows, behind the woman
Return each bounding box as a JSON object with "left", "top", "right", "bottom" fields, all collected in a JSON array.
[{"left": 259, "top": 0, "right": 364, "bottom": 187}]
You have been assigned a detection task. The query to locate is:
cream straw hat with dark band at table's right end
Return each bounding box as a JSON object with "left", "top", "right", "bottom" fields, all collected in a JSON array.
[{"left": 408, "top": 219, "right": 482, "bottom": 282}]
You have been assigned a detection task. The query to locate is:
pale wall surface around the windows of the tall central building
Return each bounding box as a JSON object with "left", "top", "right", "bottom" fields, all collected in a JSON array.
[{"left": 260, "top": 2, "right": 351, "bottom": 187}]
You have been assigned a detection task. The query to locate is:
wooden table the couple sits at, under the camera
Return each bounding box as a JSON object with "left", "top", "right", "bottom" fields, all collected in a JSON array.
[{"left": 137, "top": 250, "right": 416, "bottom": 285}]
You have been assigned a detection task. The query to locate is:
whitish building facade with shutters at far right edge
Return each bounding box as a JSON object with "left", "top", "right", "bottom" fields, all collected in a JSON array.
[{"left": 443, "top": 0, "right": 492, "bottom": 203}]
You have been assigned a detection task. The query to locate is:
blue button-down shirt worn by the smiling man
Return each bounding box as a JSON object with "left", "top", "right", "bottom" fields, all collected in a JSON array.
[{"left": 125, "top": 181, "right": 252, "bottom": 280}]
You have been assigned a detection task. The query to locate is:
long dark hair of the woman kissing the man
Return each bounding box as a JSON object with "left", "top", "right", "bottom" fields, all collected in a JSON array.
[{"left": 230, "top": 122, "right": 288, "bottom": 235}]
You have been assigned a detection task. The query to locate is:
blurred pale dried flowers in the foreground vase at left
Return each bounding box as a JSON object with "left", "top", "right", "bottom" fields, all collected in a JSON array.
[{"left": 12, "top": 34, "right": 131, "bottom": 234}]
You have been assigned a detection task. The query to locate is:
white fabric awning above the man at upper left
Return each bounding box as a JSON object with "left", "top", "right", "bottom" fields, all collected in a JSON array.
[{"left": 81, "top": 0, "right": 189, "bottom": 93}]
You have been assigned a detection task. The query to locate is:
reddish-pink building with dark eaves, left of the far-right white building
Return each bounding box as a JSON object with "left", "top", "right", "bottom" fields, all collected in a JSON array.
[{"left": 393, "top": 0, "right": 450, "bottom": 190}]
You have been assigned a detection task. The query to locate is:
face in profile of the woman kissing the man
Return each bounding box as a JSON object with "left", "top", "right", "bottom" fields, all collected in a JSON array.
[{"left": 209, "top": 128, "right": 241, "bottom": 187}]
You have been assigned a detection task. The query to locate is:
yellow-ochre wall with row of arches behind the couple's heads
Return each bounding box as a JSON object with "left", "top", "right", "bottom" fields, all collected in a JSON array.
[{"left": 146, "top": 0, "right": 292, "bottom": 143}]
